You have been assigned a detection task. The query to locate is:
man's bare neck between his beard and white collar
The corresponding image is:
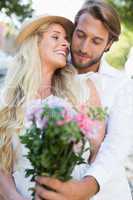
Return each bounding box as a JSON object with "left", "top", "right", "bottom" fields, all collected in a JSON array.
[{"left": 78, "top": 63, "right": 100, "bottom": 74}]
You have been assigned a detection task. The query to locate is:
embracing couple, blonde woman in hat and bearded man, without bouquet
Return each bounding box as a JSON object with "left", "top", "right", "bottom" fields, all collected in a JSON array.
[{"left": 0, "top": 1, "right": 133, "bottom": 200}]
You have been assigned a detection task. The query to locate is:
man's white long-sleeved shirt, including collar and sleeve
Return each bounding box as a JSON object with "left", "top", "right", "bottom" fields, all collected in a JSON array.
[{"left": 75, "top": 58, "right": 133, "bottom": 200}]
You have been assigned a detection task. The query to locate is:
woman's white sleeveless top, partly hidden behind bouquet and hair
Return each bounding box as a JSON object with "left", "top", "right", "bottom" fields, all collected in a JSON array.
[{"left": 13, "top": 76, "right": 90, "bottom": 199}]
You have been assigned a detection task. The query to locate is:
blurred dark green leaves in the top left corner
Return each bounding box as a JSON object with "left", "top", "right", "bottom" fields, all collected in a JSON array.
[{"left": 0, "top": 0, "right": 33, "bottom": 21}]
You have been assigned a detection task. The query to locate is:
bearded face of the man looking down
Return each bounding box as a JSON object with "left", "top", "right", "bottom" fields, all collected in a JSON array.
[{"left": 71, "top": 13, "right": 110, "bottom": 71}]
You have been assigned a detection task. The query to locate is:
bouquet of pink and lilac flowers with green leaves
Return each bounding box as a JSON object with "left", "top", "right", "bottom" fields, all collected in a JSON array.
[{"left": 20, "top": 96, "right": 106, "bottom": 198}]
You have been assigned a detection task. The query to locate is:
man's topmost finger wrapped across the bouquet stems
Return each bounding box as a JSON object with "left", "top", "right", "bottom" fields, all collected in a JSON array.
[{"left": 36, "top": 177, "right": 64, "bottom": 191}]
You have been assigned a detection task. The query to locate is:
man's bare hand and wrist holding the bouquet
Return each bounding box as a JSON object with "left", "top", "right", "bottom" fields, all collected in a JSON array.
[{"left": 35, "top": 176, "right": 99, "bottom": 200}]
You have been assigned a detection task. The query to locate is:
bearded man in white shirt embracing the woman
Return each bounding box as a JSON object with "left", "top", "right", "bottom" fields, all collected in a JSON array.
[{"left": 36, "top": 1, "right": 133, "bottom": 200}]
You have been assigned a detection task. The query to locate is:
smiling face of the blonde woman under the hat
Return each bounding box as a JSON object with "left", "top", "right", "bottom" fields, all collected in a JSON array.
[{"left": 39, "top": 24, "right": 69, "bottom": 70}]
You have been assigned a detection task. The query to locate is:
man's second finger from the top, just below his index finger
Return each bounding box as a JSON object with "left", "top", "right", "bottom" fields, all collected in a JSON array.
[{"left": 36, "top": 185, "right": 65, "bottom": 200}]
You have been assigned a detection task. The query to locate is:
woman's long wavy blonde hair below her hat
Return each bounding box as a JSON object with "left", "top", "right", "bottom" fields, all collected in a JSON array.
[{"left": 0, "top": 21, "right": 76, "bottom": 173}]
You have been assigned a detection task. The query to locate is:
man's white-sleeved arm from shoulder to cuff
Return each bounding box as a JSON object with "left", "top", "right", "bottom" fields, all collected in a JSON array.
[{"left": 82, "top": 80, "right": 133, "bottom": 188}]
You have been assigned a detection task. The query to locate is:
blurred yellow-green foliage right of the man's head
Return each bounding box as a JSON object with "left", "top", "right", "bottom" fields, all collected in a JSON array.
[{"left": 107, "top": 0, "right": 133, "bottom": 69}]
